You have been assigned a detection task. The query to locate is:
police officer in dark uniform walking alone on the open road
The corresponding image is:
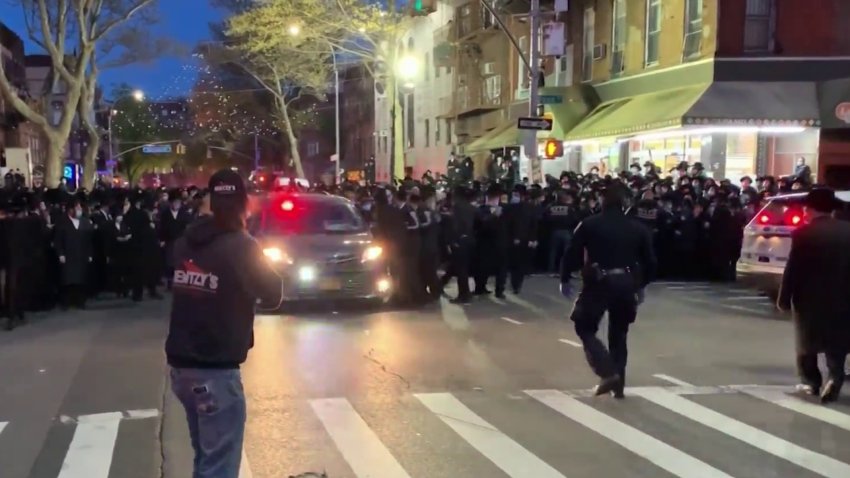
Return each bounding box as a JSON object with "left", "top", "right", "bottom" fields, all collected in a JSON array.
[{"left": 561, "top": 184, "right": 656, "bottom": 398}]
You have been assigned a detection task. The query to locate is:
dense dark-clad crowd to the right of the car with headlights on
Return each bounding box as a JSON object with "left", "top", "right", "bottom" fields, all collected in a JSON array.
[{"left": 343, "top": 158, "right": 811, "bottom": 303}]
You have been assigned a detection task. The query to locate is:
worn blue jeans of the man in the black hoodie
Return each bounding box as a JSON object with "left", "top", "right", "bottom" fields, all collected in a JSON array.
[{"left": 171, "top": 368, "right": 246, "bottom": 478}]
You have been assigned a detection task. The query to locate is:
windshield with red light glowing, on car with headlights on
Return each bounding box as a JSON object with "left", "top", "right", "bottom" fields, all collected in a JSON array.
[{"left": 263, "top": 200, "right": 366, "bottom": 234}]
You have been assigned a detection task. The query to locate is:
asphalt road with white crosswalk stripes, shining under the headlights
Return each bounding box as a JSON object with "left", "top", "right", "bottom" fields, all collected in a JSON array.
[{"left": 0, "top": 277, "right": 850, "bottom": 478}]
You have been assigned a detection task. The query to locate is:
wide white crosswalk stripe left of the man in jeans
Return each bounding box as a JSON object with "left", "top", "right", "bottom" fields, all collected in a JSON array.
[{"left": 58, "top": 412, "right": 122, "bottom": 478}]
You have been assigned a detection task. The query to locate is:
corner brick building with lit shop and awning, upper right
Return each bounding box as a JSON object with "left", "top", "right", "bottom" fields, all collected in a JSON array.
[{"left": 547, "top": 0, "right": 850, "bottom": 185}]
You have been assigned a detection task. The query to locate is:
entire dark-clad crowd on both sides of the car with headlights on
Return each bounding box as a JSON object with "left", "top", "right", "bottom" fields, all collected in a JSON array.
[{"left": 0, "top": 158, "right": 810, "bottom": 328}]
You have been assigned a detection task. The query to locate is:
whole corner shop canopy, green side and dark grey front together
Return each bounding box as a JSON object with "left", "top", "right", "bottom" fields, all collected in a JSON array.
[{"left": 566, "top": 82, "right": 820, "bottom": 141}]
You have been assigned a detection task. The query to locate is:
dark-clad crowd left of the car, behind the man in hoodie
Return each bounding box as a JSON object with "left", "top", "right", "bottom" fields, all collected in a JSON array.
[{"left": 0, "top": 182, "right": 208, "bottom": 329}]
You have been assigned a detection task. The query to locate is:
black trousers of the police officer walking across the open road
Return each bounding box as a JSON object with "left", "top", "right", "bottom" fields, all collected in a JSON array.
[{"left": 570, "top": 275, "right": 637, "bottom": 383}]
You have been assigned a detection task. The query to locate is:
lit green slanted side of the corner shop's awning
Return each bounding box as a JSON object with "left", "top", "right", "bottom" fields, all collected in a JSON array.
[{"left": 566, "top": 84, "right": 710, "bottom": 141}]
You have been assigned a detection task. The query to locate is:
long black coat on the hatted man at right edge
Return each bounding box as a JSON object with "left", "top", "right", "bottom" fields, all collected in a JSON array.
[{"left": 779, "top": 217, "right": 850, "bottom": 353}]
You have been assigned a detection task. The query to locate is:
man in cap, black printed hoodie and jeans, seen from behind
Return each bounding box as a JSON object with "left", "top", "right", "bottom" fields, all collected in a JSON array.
[{"left": 165, "top": 170, "right": 282, "bottom": 478}]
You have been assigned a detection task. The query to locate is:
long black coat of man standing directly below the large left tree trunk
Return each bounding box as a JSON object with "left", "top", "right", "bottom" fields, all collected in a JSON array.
[{"left": 53, "top": 216, "right": 94, "bottom": 285}]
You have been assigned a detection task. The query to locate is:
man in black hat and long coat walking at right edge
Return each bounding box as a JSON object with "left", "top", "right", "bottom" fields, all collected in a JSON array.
[{"left": 777, "top": 188, "right": 850, "bottom": 403}]
